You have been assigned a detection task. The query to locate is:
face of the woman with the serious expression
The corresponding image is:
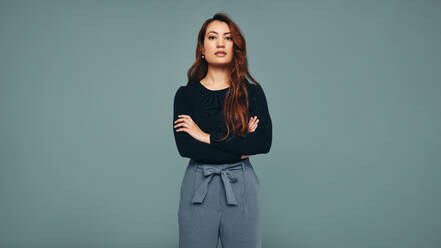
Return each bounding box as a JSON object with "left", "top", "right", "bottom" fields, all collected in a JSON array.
[{"left": 202, "top": 20, "right": 233, "bottom": 65}]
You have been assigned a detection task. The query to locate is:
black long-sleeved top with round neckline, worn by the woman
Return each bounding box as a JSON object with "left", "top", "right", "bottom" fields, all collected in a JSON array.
[{"left": 172, "top": 81, "right": 272, "bottom": 164}]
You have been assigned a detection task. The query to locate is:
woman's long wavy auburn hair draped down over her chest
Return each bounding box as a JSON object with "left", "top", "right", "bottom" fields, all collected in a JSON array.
[{"left": 187, "top": 13, "right": 260, "bottom": 140}]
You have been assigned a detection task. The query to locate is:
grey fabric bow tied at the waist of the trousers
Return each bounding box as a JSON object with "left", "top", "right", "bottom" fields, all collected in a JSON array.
[{"left": 192, "top": 162, "right": 245, "bottom": 205}]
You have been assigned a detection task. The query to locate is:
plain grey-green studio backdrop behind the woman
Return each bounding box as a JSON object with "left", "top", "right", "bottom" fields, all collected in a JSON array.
[{"left": 0, "top": 0, "right": 441, "bottom": 248}]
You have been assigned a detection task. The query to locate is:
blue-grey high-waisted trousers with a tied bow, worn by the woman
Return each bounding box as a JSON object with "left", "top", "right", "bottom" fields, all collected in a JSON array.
[{"left": 178, "top": 158, "right": 262, "bottom": 248}]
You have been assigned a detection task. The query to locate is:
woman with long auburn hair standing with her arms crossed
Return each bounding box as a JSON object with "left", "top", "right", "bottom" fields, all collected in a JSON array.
[{"left": 173, "top": 13, "right": 272, "bottom": 248}]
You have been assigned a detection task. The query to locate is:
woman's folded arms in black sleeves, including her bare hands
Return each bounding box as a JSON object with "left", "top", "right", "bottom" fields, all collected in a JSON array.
[{"left": 173, "top": 86, "right": 272, "bottom": 163}]
